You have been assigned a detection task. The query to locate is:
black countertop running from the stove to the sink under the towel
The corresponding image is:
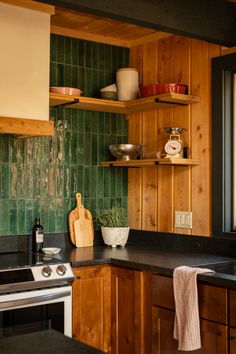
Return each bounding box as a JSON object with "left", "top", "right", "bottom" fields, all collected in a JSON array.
[{"left": 58, "top": 244, "right": 236, "bottom": 289}]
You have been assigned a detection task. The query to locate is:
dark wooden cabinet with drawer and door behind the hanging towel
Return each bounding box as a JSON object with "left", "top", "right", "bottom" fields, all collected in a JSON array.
[{"left": 152, "top": 275, "right": 229, "bottom": 354}]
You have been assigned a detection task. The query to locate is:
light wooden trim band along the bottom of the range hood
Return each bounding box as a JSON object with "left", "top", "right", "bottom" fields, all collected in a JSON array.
[{"left": 0, "top": 117, "right": 54, "bottom": 137}]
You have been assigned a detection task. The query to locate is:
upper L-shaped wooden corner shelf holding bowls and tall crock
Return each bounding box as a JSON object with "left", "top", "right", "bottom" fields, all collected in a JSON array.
[{"left": 50, "top": 92, "right": 200, "bottom": 114}]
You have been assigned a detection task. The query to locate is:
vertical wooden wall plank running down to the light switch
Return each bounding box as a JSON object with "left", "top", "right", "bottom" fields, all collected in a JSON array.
[{"left": 173, "top": 36, "right": 192, "bottom": 234}]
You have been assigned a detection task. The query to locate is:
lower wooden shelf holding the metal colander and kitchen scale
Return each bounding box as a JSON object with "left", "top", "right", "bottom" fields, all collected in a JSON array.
[{"left": 100, "top": 158, "right": 198, "bottom": 167}]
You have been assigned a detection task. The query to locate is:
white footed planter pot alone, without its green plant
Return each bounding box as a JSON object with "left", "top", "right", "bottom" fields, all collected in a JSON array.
[{"left": 101, "top": 227, "right": 130, "bottom": 247}]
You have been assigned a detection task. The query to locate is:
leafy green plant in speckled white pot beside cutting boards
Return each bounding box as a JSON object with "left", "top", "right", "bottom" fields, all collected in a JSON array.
[{"left": 95, "top": 207, "right": 130, "bottom": 247}]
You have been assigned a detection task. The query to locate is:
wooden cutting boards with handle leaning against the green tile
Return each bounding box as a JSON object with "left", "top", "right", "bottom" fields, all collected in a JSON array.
[{"left": 69, "top": 193, "right": 94, "bottom": 247}]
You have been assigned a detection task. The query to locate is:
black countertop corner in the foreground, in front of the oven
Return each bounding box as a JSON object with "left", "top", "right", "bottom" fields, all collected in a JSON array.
[{"left": 0, "top": 329, "right": 104, "bottom": 354}]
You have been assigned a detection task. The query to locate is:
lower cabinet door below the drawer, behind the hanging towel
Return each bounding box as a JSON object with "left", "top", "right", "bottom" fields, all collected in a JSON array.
[{"left": 152, "top": 306, "right": 228, "bottom": 354}]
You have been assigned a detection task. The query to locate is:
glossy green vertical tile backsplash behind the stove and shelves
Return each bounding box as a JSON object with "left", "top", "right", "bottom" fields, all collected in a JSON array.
[{"left": 0, "top": 35, "right": 129, "bottom": 236}]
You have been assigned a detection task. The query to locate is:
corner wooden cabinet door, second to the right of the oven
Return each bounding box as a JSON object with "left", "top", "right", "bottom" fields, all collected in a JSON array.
[{"left": 111, "top": 267, "right": 151, "bottom": 354}]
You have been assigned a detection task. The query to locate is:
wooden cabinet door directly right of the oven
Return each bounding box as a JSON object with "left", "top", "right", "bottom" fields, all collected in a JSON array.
[{"left": 73, "top": 266, "right": 111, "bottom": 353}]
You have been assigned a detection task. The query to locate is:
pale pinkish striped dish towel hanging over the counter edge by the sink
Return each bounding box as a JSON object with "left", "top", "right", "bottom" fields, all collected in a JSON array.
[{"left": 173, "top": 266, "right": 214, "bottom": 351}]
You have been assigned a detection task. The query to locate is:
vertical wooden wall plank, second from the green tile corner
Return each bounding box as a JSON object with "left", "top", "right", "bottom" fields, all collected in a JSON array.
[{"left": 142, "top": 41, "right": 158, "bottom": 231}]
